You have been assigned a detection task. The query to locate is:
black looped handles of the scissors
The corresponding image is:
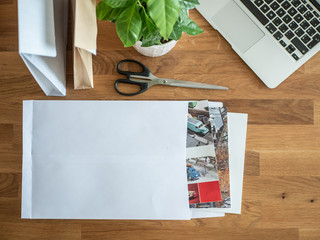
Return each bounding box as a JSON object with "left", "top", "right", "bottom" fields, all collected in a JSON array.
[{"left": 114, "top": 59, "right": 151, "bottom": 96}]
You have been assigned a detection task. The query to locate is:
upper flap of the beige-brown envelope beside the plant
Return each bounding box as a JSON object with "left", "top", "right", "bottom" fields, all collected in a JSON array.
[{"left": 74, "top": 0, "right": 97, "bottom": 54}]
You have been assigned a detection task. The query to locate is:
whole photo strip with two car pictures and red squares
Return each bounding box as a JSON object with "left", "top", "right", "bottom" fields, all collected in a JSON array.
[{"left": 186, "top": 101, "right": 222, "bottom": 204}]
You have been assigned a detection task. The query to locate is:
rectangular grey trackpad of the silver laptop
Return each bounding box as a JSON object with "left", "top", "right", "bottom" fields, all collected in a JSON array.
[{"left": 212, "top": 1, "right": 265, "bottom": 53}]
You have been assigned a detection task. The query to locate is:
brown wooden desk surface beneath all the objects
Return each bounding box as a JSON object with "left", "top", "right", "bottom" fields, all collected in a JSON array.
[{"left": 0, "top": 0, "right": 320, "bottom": 240}]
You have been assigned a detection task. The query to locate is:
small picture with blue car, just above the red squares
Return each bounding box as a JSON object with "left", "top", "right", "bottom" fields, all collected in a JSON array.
[{"left": 187, "top": 156, "right": 219, "bottom": 183}]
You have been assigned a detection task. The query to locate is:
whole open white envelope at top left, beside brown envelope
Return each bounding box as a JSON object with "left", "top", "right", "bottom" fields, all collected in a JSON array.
[{"left": 18, "top": 0, "right": 69, "bottom": 96}]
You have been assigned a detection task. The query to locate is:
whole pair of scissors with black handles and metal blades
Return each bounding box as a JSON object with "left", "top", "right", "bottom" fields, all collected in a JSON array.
[{"left": 114, "top": 59, "right": 228, "bottom": 96}]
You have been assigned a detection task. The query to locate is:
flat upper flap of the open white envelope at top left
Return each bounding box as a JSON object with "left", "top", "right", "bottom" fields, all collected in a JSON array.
[{"left": 18, "top": 0, "right": 57, "bottom": 57}]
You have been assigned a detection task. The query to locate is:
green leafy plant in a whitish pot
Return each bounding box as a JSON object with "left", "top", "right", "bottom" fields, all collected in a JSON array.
[{"left": 97, "top": 0, "right": 203, "bottom": 57}]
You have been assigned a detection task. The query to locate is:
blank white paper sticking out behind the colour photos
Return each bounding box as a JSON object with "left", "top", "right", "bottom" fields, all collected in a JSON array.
[{"left": 192, "top": 113, "right": 248, "bottom": 217}]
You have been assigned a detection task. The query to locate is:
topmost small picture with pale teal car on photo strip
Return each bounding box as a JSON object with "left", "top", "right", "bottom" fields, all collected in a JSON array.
[{"left": 187, "top": 101, "right": 214, "bottom": 148}]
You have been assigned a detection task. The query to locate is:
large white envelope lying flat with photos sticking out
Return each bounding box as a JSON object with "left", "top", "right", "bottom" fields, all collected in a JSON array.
[{"left": 22, "top": 101, "right": 190, "bottom": 219}]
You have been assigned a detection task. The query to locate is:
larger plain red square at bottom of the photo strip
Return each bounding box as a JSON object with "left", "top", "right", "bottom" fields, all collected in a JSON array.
[{"left": 199, "top": 181, "right": 221, "bottom": 203}]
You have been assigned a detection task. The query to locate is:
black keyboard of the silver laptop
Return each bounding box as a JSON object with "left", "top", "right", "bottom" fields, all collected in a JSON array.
[{"left": 240, "top": 0, "right": 320, "bottom": 61}]
